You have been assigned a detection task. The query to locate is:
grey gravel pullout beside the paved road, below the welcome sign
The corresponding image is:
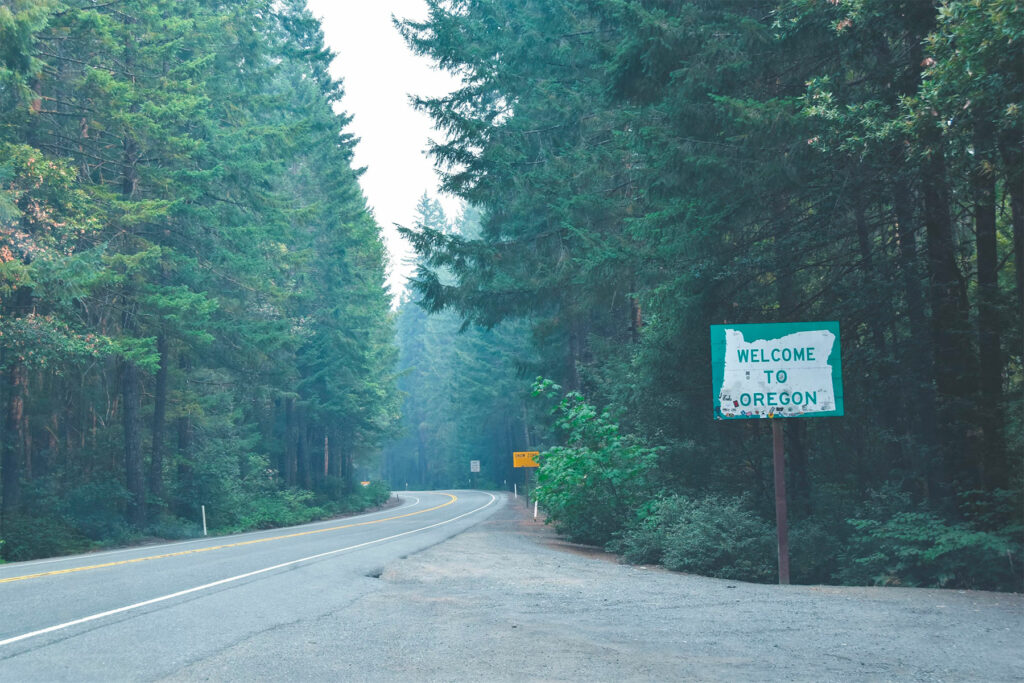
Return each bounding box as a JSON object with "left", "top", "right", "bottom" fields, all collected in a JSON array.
[{"left": 176, "top": 493, "right": 1024, "bottom": 681}]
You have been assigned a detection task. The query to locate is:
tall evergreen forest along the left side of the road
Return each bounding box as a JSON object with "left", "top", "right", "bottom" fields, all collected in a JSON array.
[{"left": 0, "top": 0, "right": 399, "bottom": 560}]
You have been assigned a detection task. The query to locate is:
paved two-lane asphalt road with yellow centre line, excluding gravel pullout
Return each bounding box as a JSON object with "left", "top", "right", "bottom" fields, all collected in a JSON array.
[{"left": 0, "top": 492, "right": 505, "bottom": 681}]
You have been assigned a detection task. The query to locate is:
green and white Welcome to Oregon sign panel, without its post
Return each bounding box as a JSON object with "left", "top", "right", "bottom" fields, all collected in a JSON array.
[{"left": 711, "top": 323, "right": 843, "bottom": 420}]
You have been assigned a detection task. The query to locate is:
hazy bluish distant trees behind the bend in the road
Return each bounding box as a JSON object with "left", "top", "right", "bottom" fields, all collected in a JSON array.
[{"left": 384, "top": 195, "right": 537, "bottom": 489}]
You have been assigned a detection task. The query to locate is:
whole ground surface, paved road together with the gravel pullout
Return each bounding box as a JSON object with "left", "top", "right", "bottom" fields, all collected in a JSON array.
[{"left": 0, "top": 492, "right": 1024, "bottom": 683}]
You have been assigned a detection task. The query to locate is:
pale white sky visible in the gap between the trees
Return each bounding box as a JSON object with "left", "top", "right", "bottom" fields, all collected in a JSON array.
[{"left": 308, "top": 0, "right": 460, "bottom": 297}]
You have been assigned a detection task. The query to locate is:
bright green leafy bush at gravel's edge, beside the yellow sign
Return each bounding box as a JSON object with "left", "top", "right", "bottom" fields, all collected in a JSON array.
[{"left": 534, "top": 379, "right": 657, "bottom": 545}]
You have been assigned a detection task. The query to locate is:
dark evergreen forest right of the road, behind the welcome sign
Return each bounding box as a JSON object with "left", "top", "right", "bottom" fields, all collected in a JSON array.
[{"left": 397, "top": 0, "right": 1024, "bottom": 590}]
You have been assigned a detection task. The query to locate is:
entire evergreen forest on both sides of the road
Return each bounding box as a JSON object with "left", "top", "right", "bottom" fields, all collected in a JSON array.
[{"left": 0, "top": 0, "right": 1024, "bottom": 591}]
